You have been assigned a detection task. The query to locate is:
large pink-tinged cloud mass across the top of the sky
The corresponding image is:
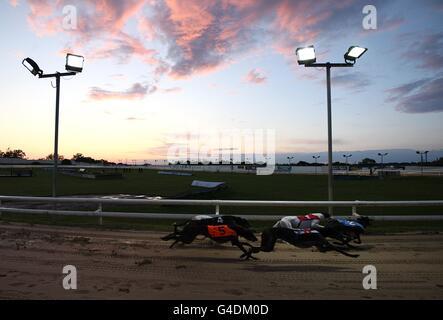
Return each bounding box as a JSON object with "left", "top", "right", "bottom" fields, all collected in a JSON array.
[{"left": 21, "top": 0, "right": 388, "bottom": 78}]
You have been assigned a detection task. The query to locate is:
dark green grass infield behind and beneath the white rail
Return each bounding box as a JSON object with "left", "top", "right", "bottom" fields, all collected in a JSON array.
[{"left": 0, "top": 169, "right": 443, "bottom": 233}]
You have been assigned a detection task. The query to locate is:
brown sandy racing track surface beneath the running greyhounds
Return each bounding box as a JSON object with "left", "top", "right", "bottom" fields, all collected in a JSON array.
[{"left": 0, "top": 224, "right": 443, "bottom": 299}]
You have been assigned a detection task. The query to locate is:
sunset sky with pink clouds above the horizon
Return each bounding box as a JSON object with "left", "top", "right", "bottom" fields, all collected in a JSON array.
[{"left": 0, "top": 0, "right": 443, "bottom": 161}]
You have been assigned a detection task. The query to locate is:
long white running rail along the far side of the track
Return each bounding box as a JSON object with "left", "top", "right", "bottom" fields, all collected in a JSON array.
[{"left": 0, "top": 196, "right": 443, "bottom": 224}]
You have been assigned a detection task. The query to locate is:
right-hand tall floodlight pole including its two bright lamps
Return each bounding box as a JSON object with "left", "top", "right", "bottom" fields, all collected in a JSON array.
[{"left": 296, "top": 46, "right": 367, "bottom": 216}]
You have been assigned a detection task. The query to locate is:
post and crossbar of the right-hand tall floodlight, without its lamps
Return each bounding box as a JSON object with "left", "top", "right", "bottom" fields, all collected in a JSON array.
[{"left": 305, "top": 62, "right": 354, "bottom": 216}]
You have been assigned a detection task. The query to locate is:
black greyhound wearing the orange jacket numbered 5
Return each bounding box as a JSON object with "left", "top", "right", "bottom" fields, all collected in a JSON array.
[{"left": 161, "top": 216, "right": 257, "bottom": 260}]
